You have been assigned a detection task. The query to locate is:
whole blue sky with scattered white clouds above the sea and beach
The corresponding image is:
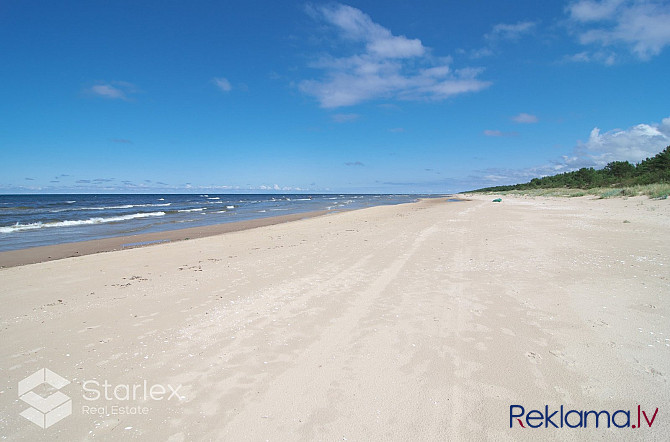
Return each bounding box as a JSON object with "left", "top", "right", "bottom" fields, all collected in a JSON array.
[{"left": 0, "top": 0, "right": 670, "bottom": 193}]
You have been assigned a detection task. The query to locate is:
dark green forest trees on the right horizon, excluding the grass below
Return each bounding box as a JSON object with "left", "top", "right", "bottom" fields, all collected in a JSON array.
[{"left": 475, "top": 146, "right": 670, "bottom": 192}]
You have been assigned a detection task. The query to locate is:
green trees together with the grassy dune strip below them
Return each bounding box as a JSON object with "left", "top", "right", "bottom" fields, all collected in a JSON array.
[{"left": 474, "top": 146, "right": 670, "bottom": 198}]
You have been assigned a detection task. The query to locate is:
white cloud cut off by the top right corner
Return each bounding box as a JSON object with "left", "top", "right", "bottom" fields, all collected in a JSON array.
[{"left": 567, "top": 0, "right": 670, "bottom": 61}]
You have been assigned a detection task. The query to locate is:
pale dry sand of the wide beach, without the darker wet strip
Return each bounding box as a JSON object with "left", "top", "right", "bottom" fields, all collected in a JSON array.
[{"left": 0, "top": 196, "right": 670, "bottom": 441}]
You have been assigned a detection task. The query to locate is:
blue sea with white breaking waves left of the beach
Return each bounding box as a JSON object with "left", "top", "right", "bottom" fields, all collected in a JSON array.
[{"left": 0, "top": 194, "right": 436, "bottom": 251}]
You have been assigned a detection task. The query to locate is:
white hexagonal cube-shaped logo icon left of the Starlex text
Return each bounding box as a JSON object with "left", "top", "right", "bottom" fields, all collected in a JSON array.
[{"left": 19, "top": 368, "right": 72, "bottom": 428}]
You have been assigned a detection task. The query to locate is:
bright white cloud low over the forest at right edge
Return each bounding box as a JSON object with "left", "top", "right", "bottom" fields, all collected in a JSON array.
[{"left": 563, "top": 117, "right": 670, "bottom": 169}]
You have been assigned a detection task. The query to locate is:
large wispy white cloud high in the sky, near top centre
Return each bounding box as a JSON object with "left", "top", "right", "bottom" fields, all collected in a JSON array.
[{"left": 299, "top": 4, "right": 490, "bottom": 108}]
